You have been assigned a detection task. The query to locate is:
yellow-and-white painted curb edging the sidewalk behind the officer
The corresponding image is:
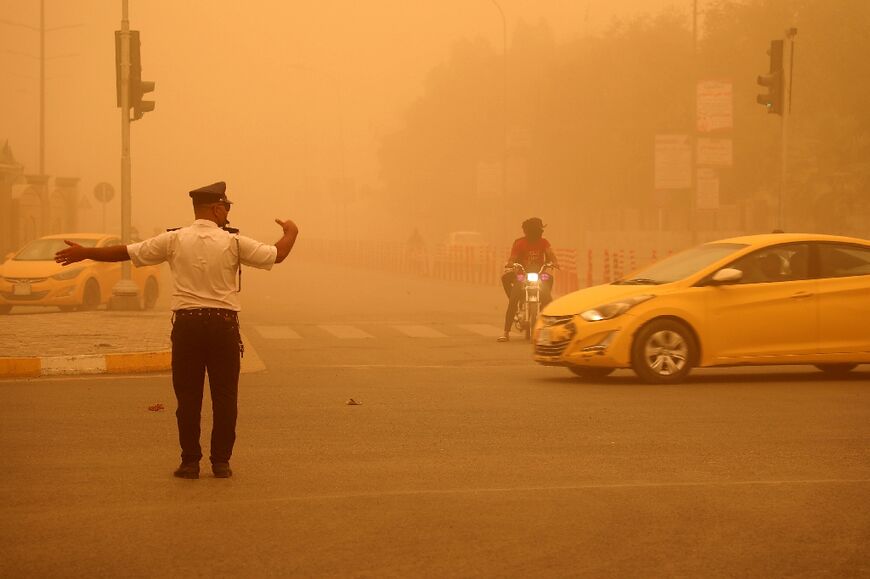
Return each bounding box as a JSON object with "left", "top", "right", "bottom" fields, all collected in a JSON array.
[{"left": 0, "top": 333, "right": 266, "bottom": 379}]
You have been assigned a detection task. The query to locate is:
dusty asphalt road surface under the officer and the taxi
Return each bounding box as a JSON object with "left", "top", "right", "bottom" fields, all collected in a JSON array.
[{"left": 0, "top": 263, "right": 870, "bottom": 577}]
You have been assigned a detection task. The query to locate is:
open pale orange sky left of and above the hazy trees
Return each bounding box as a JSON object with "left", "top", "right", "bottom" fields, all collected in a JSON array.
[{"left": 0, "top": 0, "right": 676, "bottom": 236}]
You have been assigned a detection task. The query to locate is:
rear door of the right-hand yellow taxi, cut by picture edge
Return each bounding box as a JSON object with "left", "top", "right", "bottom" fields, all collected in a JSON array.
[{"left": 814, "top": 242, "right": 870, "bottom": 354}]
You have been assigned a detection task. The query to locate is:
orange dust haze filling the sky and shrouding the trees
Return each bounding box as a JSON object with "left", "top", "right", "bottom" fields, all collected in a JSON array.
[{"left": 0, "top": 0, "right": 870, "bottom": 268}]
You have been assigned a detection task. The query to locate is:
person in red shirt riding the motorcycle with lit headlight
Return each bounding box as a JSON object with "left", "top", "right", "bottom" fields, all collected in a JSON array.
[{"left": 498, "top": 217, "right": 559, "bottom": 342}]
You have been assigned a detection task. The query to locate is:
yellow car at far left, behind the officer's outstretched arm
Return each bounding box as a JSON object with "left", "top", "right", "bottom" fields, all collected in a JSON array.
[{"left": 0, "top": 233, "right": 160, "bottom": 314}]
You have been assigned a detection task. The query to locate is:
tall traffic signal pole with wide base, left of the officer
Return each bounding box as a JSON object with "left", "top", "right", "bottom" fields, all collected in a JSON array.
[{"left": 109, "top": 0, "right": 139, "bottom": 310}]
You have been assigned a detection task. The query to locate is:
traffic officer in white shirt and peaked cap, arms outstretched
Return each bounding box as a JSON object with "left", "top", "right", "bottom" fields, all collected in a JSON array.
[{"left": 55, "top": 182, "right": 299, "bottom": 479}]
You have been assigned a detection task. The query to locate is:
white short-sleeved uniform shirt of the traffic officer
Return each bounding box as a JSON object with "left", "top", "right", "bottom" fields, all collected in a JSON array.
[{"left": 127, "top": 219, "right": 278, "bottom": 312}]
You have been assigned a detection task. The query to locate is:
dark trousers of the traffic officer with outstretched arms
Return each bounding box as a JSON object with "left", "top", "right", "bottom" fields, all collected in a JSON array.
[{"left": 172, "top": 310, "right": 240, "bottom": 463}]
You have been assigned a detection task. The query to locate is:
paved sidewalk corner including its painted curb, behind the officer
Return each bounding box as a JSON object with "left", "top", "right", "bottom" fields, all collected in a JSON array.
[{"left": 0, "top": 308, "right": 264, "bottom": 379}]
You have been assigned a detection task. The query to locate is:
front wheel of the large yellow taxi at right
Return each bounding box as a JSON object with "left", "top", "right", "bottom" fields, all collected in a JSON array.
[{"left": 631, "top": 320, "right": 698, "bottom": 384}]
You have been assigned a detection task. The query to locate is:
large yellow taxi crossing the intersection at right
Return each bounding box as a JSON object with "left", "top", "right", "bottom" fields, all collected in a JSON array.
[{"left": 534, "top": 233, "right": 870, "bottom": 383}]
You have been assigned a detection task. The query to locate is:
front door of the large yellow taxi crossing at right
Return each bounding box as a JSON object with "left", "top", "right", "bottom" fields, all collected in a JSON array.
[{"left": 702, "top": 243, "right": 818, "bottom": 363}]
